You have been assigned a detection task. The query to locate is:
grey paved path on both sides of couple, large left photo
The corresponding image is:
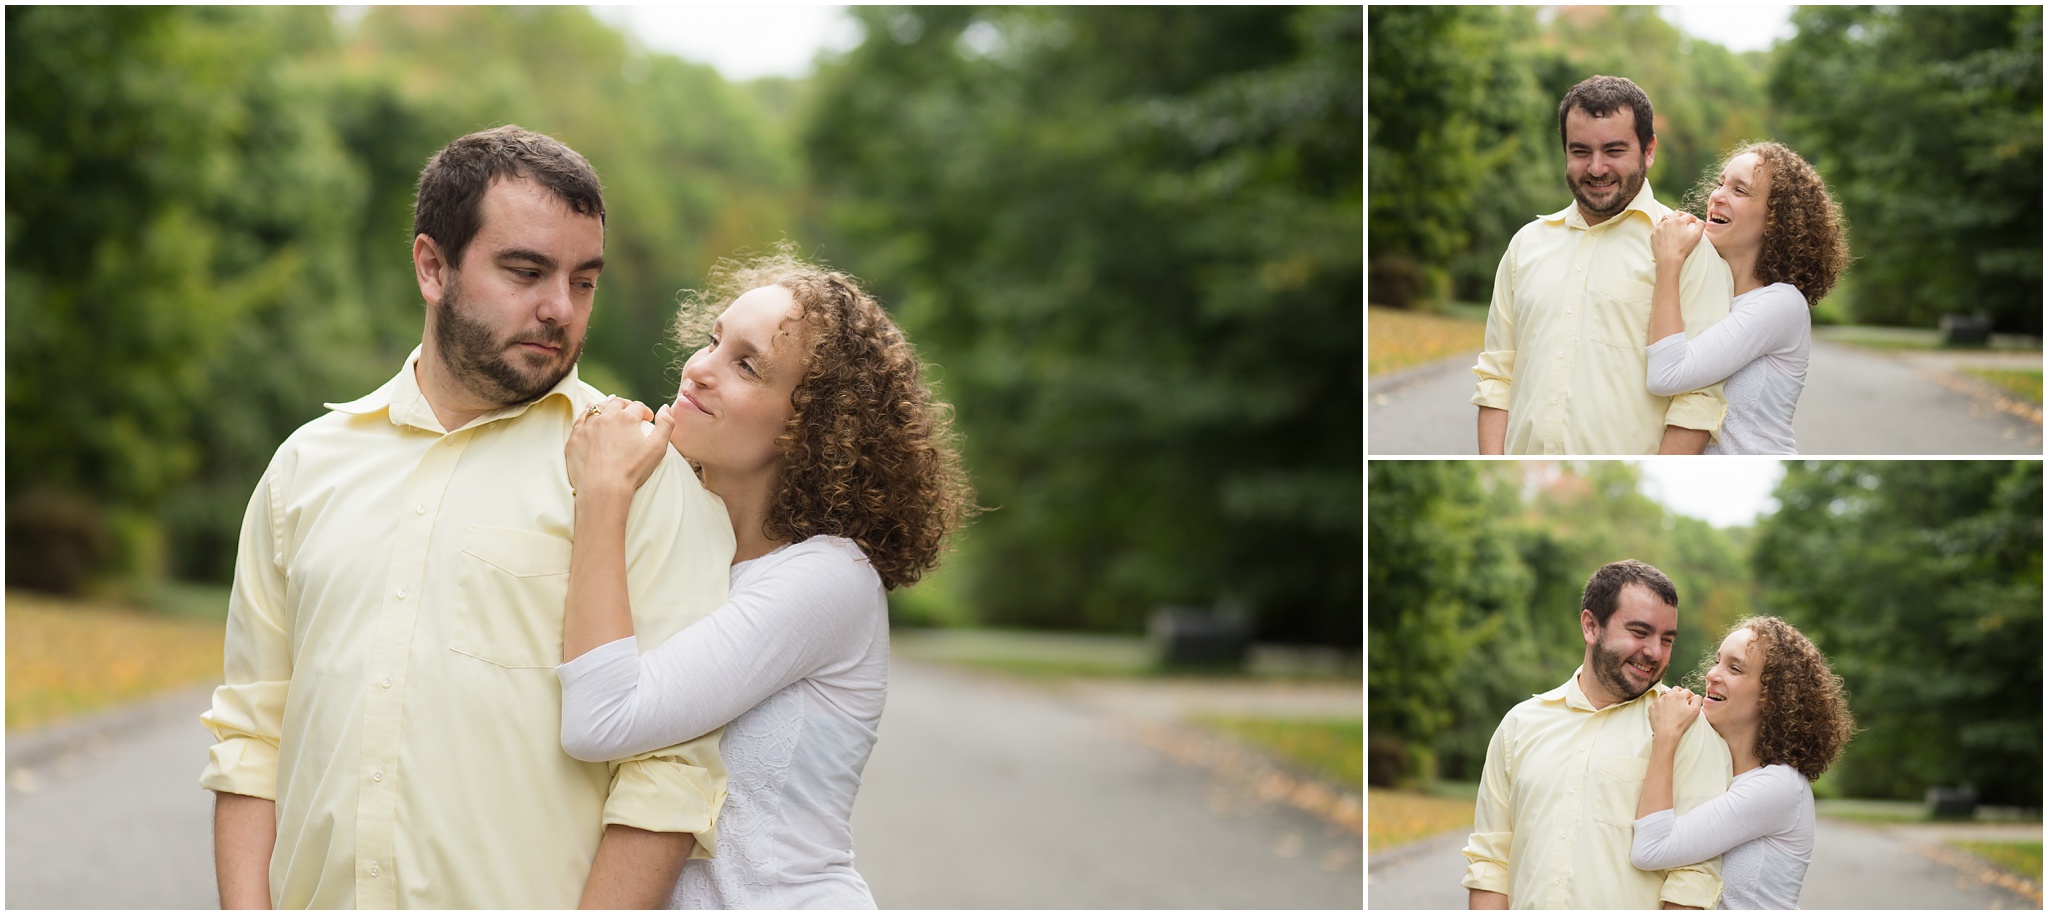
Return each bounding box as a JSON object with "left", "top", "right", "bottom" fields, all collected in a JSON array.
[{"left": 6, "top": 661, "right": 1364, "bottom": 909}]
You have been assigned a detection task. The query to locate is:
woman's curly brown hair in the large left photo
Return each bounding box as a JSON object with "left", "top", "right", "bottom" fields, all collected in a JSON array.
[{"left": 674, "top": 242, "right": 975, "bottom": 590}]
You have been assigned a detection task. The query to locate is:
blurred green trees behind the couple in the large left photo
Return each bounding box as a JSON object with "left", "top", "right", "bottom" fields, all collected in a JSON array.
[{"left": 6, "top": 6, "right": 1364, "bottom": 647}]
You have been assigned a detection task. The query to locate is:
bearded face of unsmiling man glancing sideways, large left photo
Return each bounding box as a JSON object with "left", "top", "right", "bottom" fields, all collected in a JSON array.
[{"left": 432, "top": 178, "right": 604, "bottom": 405}]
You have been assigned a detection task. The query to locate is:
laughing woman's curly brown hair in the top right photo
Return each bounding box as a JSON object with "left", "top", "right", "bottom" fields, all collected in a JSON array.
[{"left": 1686, "top": 141, "right": 1849, "bottom": 307}]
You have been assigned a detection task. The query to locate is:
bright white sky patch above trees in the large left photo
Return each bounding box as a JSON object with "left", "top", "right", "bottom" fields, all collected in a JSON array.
[{"left": 590, "top": 4, "right": 860, "bottom": 80}]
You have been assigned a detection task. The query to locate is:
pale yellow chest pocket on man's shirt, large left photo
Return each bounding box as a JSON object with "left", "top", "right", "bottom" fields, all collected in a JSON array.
[{"left": 449, "top": 528, "right": 569, "bottom": 669}]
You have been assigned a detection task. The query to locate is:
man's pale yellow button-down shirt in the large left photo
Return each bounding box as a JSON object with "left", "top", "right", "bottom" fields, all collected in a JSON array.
[{"left": 201, "top": 350, "right": 733, "bottom": 909}]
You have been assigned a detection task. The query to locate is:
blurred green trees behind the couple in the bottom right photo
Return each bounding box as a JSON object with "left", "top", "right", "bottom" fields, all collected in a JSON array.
[{"left": 1366, "top": 461, "right": 2042, "bottom": 807}]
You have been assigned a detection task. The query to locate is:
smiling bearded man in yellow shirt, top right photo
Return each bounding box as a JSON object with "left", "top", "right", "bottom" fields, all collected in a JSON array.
[{"left": 1473, "top": 76, "right": 1735, "bottom": 454}]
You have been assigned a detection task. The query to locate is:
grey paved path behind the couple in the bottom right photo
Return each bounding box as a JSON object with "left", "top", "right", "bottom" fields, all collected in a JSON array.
[{"left": 1366, "top": 817, "right": 2042, "bottom": 909}]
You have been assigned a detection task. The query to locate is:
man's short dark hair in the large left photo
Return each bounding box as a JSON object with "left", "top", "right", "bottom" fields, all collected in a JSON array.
[{"left": 412, "top": 125, "right": 604, "bottom": 266}]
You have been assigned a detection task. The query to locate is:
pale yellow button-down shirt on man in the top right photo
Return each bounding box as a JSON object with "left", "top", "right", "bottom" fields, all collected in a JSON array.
[{"left": 1473, "top": 182, "right": 1735, "bottom": 454}]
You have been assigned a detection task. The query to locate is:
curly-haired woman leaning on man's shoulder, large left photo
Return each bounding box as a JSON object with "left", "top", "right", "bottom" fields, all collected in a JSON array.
[{"left": 559, "top": 250, "right": 971, "bottom": 909}]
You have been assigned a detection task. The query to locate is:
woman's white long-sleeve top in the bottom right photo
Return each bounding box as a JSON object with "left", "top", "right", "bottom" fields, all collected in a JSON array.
[{"left": 1628, "top": 766, "right": 1815, "bottom": 909}]
